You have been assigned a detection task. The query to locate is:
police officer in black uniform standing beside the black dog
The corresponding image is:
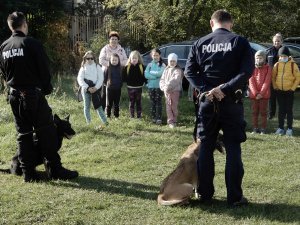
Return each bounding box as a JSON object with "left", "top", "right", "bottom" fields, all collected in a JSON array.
[{"left": 0, "top": 12, "right": 78, "bottom": 182}]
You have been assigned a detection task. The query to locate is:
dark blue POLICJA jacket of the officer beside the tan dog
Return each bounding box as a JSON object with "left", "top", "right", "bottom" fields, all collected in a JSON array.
[{"left": 185, "top": 28, "right": 254, "bottom": 95}]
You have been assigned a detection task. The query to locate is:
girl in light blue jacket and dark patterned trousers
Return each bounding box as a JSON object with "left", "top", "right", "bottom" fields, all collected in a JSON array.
[{"left": 145, "top": 49, "right": 166, "bottom": 125}]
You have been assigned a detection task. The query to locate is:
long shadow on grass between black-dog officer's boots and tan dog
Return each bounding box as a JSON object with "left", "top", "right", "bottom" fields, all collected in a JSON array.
[{"left": 51, "top": 176, "right": 159, "bottom": 200}]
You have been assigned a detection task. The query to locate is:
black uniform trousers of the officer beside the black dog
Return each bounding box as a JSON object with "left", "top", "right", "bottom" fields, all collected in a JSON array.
[{"left": 9, "top": 88, "right": 61, "bottom": 172}]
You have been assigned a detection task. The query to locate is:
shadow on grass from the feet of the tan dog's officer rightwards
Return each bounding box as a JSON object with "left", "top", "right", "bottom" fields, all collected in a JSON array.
[{"left": 186, "top": 199, "right": 300, "bottom": 223}]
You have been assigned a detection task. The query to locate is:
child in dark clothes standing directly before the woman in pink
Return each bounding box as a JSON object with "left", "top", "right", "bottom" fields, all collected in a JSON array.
[{"left": 104, "top": 53, "right": 123, "bottom": 118}]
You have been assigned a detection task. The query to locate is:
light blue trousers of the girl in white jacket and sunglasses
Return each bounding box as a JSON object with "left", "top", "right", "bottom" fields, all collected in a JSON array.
[{"left": 81, "top": 88, "right": 107, "bottom": 124}]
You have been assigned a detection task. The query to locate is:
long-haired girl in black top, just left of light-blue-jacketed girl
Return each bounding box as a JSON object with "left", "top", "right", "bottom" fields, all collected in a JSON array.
[{"left": 123, "top": 51, "right": 146, "bottom": 119}]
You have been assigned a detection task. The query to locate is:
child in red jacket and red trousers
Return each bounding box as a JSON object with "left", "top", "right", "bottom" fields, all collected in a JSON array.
[{"left": 249, "top": 50, "right": 272, "bottom": 134}]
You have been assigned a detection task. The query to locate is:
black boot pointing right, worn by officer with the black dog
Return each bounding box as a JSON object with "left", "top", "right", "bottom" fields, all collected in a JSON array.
[{"left": 45, "top": 164, "right": 79, "bottom": 180}]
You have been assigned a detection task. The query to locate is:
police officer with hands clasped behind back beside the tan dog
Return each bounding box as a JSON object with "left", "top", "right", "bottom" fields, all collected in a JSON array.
[{"left": 185, "top": 10, "right": 254, "bottom": 206}]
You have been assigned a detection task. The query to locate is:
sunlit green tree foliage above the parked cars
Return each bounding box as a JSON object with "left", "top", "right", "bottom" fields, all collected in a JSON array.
[{"left": 103, "top": 0, "right": 300, "bottom": 47}]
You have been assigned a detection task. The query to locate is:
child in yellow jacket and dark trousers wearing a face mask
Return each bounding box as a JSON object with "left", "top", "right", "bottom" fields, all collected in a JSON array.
[{"left": 272, "top": 46, "right": 300, "bottom": 136}]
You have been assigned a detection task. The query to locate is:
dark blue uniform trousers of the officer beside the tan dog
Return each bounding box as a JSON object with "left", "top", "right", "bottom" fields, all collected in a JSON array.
[{"left": 197, "top": 97, "right": 246, "bottom": 204}]
